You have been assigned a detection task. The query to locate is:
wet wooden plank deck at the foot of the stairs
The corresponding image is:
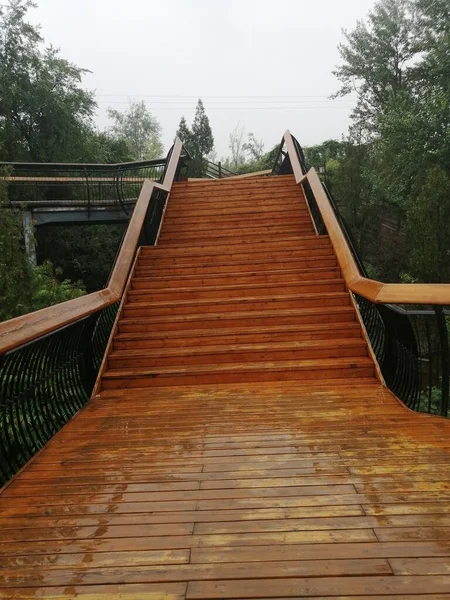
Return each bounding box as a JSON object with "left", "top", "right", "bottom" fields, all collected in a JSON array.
[{"left": 0, "top": 380, "right": 450, "bottom": 600}]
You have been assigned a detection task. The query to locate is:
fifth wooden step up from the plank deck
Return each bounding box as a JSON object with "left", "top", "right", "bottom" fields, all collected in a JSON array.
[{"left": 123, "top": 292, "right": 350, "bottom": 318}]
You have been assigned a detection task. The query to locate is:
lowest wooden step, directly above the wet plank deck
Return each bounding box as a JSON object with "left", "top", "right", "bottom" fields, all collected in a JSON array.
[{"left": 102, "top": 357, "right": 374, "bottom": 389}]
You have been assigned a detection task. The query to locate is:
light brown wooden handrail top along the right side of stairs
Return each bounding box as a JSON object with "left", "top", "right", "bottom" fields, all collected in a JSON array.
[{"left": 284, "top": 130, "right": 450, "bottom": 306}]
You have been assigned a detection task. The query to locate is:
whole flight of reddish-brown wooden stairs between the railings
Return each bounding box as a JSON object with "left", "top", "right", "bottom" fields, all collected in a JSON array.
[{"left": 101, "top": 175, "right": 375, "bottom": 389}]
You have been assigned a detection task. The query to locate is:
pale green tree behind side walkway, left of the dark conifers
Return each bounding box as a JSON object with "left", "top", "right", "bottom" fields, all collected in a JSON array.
[{"left": 108, "top": 100, "right": 163, "bottom": 160}]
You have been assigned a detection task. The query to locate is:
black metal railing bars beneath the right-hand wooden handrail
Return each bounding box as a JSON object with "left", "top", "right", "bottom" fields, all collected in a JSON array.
[{"left": 282, "top": 136, "right": 450, "bottom": 416}]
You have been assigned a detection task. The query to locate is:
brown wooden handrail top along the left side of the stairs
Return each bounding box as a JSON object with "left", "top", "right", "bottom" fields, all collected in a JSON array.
[{"left": 0, "top": 138, "right": 183, "bottom": 355}]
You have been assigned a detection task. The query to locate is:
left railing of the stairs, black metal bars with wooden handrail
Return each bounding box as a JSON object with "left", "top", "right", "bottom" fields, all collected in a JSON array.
[{"left": 0, "top": 141, "right": 185, "bottom": 486}]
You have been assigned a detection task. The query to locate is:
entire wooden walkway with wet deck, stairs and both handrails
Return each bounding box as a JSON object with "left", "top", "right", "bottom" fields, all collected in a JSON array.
[{"left": 0, "top": 133, "right": 450, "bottom": 600}]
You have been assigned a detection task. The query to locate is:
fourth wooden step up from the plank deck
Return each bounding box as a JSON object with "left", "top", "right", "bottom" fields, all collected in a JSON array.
[{"left": 118, "top": 304, "right": 356, "bottom": 333}]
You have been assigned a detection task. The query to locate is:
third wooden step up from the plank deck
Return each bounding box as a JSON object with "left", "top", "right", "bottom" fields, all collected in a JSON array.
[{"left": 114, "top": 321, "right": 361, "bottom": 350}]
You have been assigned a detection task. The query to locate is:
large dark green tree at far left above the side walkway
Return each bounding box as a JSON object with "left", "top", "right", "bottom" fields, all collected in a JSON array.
[{"left": 0, "top": 0, "right": 96, "bottom": 162}]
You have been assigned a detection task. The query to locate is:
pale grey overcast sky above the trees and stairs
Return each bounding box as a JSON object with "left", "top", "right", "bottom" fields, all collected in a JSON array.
[{"left": 30, "top": 0, "right": 374, "bottom": 158}]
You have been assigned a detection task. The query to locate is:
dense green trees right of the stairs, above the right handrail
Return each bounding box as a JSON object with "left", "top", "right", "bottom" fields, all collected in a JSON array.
[{"left": 332, "top": 0, "right": 450, "bottom": 282}]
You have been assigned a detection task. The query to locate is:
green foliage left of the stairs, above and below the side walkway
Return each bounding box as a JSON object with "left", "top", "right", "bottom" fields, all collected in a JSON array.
[{"left": 0, "top": 0, "right": 151, "bottom": 320}]
